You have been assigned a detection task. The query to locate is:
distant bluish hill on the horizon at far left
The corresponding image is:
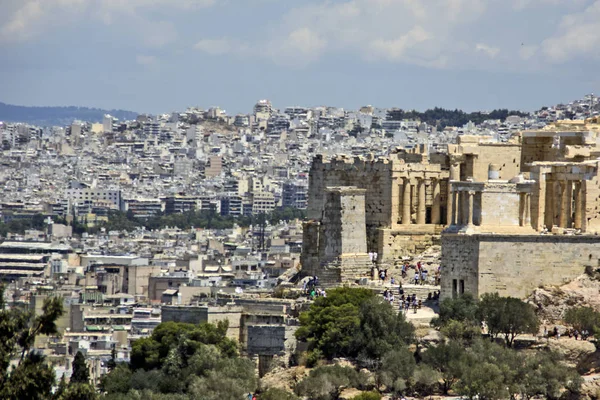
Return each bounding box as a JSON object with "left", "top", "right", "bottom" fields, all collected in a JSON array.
[{"left": 0, "top": 102, "right": 138, "bottom": 126}]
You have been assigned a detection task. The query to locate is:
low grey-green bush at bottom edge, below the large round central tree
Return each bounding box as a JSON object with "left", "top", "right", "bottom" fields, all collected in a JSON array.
[{"left": 296, "top": 365, "right": 360, "bottom": 400}]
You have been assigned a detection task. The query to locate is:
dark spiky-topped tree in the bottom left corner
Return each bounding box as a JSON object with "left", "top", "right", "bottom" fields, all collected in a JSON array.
[{"left": 0, "top": 287, "right": 63, "bottom": 400}]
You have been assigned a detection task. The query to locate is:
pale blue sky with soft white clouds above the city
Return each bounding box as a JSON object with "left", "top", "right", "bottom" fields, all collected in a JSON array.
[{"left": 0, "top": 0, "right": 600, "bottom": 114}]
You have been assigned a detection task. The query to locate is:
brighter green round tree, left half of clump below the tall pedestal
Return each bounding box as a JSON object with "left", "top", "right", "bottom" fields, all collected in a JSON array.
[{"left": 296, "top": 288, "right": 375, "bottom": 359}]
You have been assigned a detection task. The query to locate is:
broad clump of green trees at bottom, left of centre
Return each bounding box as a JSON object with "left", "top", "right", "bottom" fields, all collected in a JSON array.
[{"left": 100, "top": 322, "right": 257, "bottom": 400}]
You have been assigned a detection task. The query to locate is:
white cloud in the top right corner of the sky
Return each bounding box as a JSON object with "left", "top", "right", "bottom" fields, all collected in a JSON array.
[{"left": 542, "top": 0, "right": 600, "bottom": 63}]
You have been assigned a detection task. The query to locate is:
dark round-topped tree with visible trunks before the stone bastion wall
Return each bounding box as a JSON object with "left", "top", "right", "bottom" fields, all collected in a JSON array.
[{"left": 479, "top": 293, "right": 540, "bottom": 347}]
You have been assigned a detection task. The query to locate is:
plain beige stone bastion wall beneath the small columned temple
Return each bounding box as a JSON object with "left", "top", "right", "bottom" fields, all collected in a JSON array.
[{"left": 441, "top": 233, "right": 600, "bottom": 298}]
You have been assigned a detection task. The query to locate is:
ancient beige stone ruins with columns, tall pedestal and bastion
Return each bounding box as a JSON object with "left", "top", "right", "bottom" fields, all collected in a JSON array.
[{"left": 302, "top": 118, "right": 600, "bottom": 297}]
